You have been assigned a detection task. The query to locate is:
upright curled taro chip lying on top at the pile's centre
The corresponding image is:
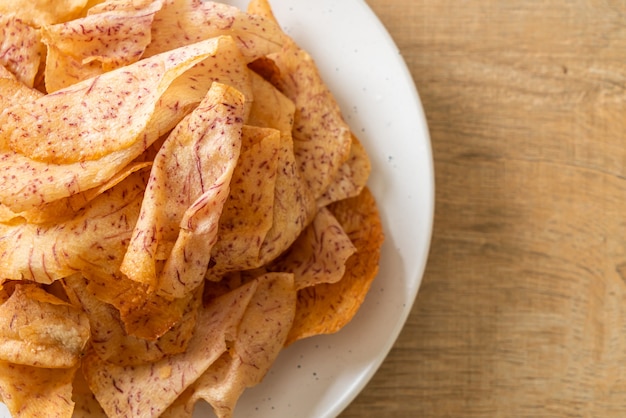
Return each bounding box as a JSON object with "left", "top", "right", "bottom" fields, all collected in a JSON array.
[{"left": 121, "top": 83, "right": 244, "bottom": 297}]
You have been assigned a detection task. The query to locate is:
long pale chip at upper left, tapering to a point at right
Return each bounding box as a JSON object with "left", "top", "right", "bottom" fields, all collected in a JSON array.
[{"left": 0, "top": 39, "right": 224, "bottom": 164}]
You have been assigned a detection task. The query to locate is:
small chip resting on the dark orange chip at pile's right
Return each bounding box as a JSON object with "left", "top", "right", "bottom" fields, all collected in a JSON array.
[{"left": 268, "top": 208, "right": 355, "bottom": 290}]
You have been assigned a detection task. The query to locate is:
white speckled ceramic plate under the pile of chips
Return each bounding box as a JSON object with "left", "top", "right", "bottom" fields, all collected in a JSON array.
[{"left": 0, "top": 0, "right": 434, "bottom": 418}]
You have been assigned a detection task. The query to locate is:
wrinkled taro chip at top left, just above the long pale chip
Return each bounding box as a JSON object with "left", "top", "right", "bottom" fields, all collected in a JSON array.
[{"left": 42, "top": 0, "right": 161, "bottom": 93}]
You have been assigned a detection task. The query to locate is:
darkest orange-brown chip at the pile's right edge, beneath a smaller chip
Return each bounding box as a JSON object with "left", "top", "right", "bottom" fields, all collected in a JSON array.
[{"left": 287, "top": 188, "right": 383, "bottom": 344}]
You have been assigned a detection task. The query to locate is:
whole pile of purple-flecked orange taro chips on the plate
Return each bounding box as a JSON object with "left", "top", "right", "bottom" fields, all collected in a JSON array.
[{"left": 0, "top": 0, "right": 383, "bottom": 418}]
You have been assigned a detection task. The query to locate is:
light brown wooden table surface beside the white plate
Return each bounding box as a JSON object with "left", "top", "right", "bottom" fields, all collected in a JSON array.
[{"left": 342, "top": 0, "right": 626, "bottom": 418}]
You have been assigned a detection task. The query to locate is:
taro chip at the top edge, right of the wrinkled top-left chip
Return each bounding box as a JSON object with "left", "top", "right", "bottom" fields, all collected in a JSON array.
[{"left": 146, "top": 0, "right": 283, "bottom": 61}]
